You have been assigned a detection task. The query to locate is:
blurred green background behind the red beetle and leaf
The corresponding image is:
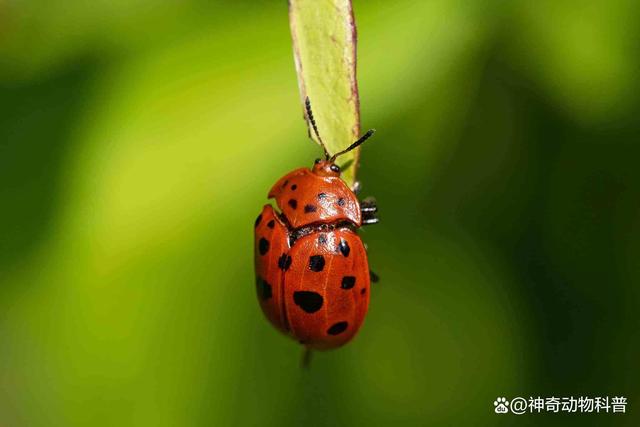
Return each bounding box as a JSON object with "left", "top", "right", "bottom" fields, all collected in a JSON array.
[{"left": 0, "top": 0, "right": 640, "bottom": 426}]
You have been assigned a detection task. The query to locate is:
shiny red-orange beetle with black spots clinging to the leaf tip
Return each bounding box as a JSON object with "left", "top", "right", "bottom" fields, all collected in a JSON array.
[{"left": 255, "top": 98, "right": 378, "bottom": 350}]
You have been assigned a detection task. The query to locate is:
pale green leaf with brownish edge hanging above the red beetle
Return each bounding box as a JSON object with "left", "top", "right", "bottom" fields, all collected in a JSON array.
[{"left": 289, "top": 0, "right": 360, "bottom": 186}]
